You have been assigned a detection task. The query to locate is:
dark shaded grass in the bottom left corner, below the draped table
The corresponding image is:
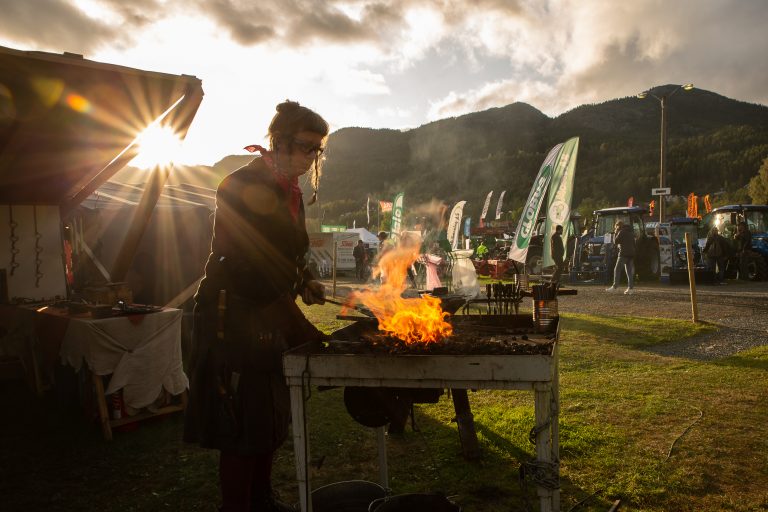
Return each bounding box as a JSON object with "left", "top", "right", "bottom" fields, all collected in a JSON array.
[{"left": 0, "top": 381, "right": 219, "bottom": 512}]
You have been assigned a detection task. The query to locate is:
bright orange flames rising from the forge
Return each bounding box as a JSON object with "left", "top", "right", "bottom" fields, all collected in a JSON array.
[{"left": 350, "top": 240, "right": 453, "bottom": 343}]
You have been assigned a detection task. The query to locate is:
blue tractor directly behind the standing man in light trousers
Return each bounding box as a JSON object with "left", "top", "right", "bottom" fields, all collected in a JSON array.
[{"left": 570, "top": 206, "right": 661, "bottom": 284}]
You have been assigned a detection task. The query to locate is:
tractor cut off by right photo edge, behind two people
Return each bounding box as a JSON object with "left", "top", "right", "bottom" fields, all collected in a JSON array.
[{"left": 699, "top": 204, "right": 768, "bottom": 281}]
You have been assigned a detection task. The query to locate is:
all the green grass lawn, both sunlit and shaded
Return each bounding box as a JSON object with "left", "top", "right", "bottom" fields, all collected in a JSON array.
[{"left": 0, "top": 304, "right": 768, "bottom": 512}]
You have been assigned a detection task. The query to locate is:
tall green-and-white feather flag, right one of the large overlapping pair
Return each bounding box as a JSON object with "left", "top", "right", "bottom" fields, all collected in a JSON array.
[{"left": 541, "top": 137, "right": 580, "bottom": 267}]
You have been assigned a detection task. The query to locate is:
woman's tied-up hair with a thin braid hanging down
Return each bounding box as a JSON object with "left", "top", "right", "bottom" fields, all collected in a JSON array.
[{"left": 268, "top": 100, "right": 330, "bottom": 204}]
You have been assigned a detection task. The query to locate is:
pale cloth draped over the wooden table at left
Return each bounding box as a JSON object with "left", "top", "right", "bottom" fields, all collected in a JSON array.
[{"left": 59, "top": 308, "right": 189, "bottom": 409}]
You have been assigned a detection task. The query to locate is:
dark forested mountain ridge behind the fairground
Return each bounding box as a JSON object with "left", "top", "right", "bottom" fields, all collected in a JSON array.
[{"left": 114, "top": 85, "right": 768, "bottom": 226}]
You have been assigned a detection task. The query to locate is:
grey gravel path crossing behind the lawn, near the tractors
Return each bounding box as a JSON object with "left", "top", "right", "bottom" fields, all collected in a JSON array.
[{"left": 325, "top": 280, "right": 768, "bottom": 360}]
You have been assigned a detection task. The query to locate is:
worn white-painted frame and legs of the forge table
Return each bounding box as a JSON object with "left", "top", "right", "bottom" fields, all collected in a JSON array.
[{"left": 283, "top": 322, "right": 560, "bottom": 512}]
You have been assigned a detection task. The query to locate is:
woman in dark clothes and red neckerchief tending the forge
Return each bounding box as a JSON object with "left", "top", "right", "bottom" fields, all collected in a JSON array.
[{"left": 184, "top": 101, "right": 328, "bottom": 512}]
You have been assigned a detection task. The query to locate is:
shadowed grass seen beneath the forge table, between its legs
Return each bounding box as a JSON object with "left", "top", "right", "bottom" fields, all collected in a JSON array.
[{"left": 298, "top": 392, "right": 612, "bottom": 512}]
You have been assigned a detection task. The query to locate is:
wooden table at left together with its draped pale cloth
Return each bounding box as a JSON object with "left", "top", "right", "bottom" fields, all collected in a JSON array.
[{"left": 33, "top": 307, "right": 189, "bottom": 440}]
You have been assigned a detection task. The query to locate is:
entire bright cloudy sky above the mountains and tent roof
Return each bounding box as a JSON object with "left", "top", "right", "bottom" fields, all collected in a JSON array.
[{"left": 0, "top": 0, "right": 768, "bottom": 164}]
